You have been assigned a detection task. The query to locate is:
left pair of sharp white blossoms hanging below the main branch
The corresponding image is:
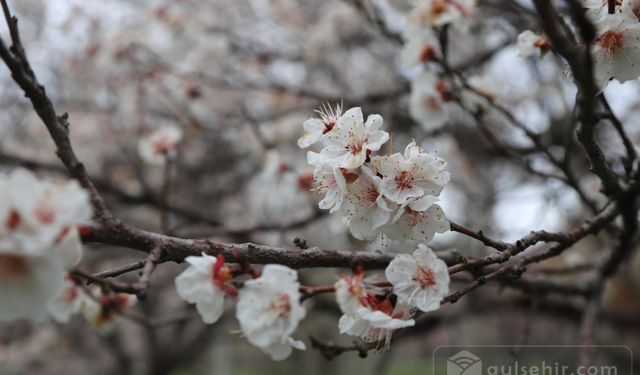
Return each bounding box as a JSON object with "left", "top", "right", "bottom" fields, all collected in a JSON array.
[{"left": 176, "top": 254, "right": 306, "bottom": 361}]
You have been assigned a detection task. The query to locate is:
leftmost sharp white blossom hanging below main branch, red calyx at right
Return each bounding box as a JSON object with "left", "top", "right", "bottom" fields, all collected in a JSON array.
[{"left": 176, "top": 253, "right": 231, "bottom": 324}]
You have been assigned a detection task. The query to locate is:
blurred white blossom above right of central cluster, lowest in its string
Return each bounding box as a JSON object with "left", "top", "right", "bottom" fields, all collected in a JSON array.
[{"left": 409, "top": 70, "right": 451, "bottom": 131}]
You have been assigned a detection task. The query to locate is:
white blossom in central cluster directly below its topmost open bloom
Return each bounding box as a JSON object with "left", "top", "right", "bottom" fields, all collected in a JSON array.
[{"left": 344, "top": 166, "right": 394, "bottom": 240}]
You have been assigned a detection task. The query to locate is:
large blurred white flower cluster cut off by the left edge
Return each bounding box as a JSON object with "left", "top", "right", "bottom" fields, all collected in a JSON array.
[{"left": 0, "top": 169, "right": 92, "bottom": 321}]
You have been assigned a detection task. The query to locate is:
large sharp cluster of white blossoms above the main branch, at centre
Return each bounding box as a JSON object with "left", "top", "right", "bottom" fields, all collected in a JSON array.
[{"left": 298, "top": 107, "right": 449, "bottom": 242}]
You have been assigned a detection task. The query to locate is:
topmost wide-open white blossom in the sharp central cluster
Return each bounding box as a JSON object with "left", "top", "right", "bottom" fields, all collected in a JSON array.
[{"left": 320, "top": 107, "right": 389, "bottom": 169}]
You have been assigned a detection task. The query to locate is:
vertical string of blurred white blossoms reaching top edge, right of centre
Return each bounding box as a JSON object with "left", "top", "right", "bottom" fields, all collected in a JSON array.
[{"left": 401, "top": 0, "right": 475, "bottom": 131}]
